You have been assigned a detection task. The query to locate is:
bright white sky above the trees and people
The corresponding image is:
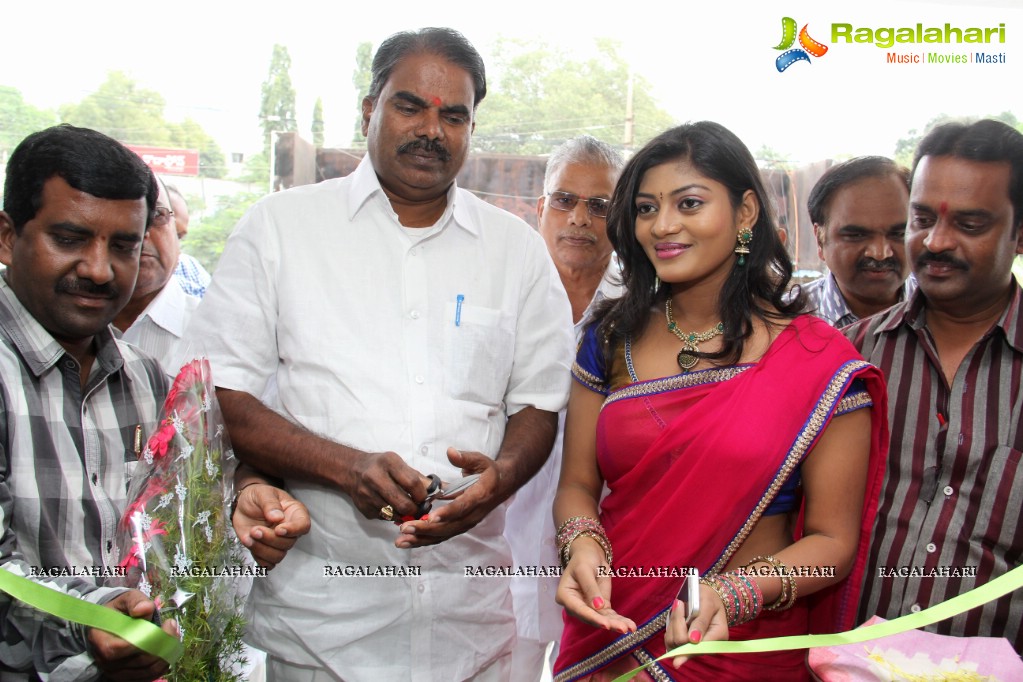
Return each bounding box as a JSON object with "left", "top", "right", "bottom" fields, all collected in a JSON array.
[{"left": 0, "top": 0, "right": 1023, "bottom": 163}]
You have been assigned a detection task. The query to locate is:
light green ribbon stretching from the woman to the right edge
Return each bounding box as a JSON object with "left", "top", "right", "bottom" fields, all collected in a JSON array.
[{"left": 614, "top": 566, "right": 1023, "bottom": 682}]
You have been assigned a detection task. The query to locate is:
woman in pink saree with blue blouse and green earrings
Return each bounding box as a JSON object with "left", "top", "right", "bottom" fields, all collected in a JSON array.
[{"left": 554, "top": 122, "right": 888, "bottom": 682}]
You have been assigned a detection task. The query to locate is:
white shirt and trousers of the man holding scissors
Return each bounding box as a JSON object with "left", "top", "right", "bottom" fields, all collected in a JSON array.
[{"left": 189, "top": 157, "right": 572, "bottom": 682}]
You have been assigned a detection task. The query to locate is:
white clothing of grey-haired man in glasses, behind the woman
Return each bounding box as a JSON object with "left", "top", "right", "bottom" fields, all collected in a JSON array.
[{"left": 504, "top": 258, "right": 622, "bottom": 662}]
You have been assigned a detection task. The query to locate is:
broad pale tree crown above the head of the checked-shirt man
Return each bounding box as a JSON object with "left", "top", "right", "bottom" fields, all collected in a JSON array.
[{"left": 59, "top": 71, "right": 227, "bottom": 178}]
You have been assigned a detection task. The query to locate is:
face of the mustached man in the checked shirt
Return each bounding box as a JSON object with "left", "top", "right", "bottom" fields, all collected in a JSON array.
[{"left": 0, "top": 176, "right": 147, "bottom": 354}]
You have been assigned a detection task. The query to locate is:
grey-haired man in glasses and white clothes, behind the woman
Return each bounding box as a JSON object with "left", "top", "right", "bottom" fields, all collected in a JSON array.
[{"left": 504, "top": 135, "right": 625, "bottom": 682}]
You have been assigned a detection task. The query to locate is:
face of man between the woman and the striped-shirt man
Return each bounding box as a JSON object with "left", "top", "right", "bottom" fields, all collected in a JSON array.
[{"left": 815, "top": 175, "right": 909, "bottom": 316}]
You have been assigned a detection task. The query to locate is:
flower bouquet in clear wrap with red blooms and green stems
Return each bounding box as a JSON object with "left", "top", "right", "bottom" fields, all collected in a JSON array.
[{"left": 119, "top": 358, "right": 244, "bottom": 682}]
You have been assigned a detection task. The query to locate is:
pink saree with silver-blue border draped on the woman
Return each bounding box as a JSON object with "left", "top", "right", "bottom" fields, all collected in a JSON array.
[{"left": 554, "top": 316, "right": 888, "bottom": 681}]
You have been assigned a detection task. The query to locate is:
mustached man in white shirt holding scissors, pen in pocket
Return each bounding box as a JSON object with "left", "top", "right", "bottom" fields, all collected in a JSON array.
[{"left": 188, "top": 29, "right": 572, "bottom": 682}]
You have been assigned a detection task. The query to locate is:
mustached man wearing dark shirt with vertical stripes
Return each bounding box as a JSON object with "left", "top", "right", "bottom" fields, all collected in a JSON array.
[{"left": 846, "top": 121, "right": 1023, "bottom": 651}]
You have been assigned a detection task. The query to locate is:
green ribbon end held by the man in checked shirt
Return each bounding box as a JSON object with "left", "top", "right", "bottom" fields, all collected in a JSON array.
[{"left": 0, "top": 569, "right": 184, "bottom": 665}]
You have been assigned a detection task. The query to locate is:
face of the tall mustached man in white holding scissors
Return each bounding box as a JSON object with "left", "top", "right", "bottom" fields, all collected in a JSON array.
[{"left": 362, "top": 53, "right": 475, "bottom": 201}]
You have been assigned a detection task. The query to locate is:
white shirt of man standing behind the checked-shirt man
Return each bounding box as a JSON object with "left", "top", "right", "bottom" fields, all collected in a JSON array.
[{"left": 121, "top": 278, "right": 199, "bottom": 377}]
